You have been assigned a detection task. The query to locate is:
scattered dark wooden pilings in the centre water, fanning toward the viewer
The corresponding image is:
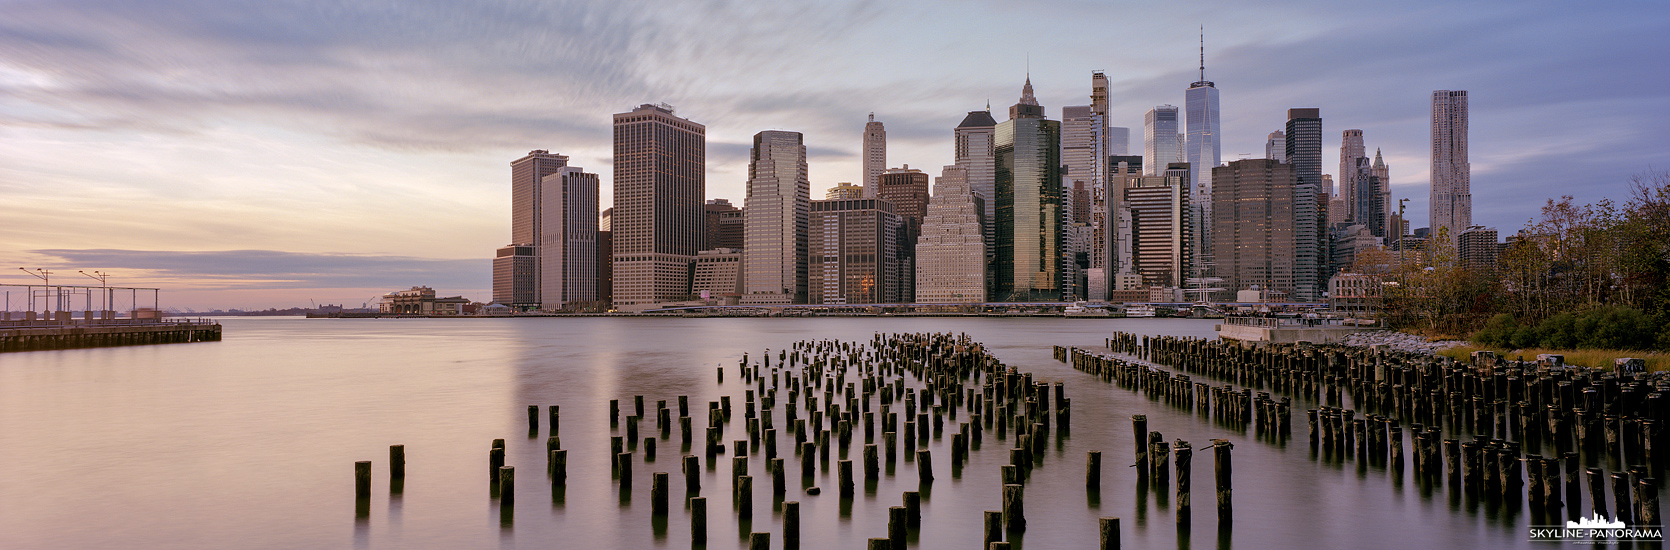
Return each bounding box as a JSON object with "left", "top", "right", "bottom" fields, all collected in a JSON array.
[{"left": 356, "top": 334, "right": 1135, "bottom": 550}]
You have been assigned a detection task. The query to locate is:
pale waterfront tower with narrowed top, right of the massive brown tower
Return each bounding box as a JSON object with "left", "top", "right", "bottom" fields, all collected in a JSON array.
[{"left": 741, "top": 130, "right": 812, "bottom": 304}]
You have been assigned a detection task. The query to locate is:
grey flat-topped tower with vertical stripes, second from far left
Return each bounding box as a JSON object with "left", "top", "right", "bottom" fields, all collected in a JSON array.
[{"left": 534, "top": 166, "right": 598, "bottom": 311}]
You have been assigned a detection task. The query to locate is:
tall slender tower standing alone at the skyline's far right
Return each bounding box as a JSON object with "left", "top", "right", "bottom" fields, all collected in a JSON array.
[{"left": 1431, "top": 90, "right": 1473, "bottom": 242}]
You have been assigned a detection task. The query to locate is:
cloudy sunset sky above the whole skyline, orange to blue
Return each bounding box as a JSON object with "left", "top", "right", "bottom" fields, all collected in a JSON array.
[{"left": 0, "top": 0, "right": 1670, "bottom": 311}]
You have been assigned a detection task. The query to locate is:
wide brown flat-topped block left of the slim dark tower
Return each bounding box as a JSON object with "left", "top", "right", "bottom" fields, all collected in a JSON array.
[{"left": 1212, "top": 158, "right": 1321, "bottom": 296}]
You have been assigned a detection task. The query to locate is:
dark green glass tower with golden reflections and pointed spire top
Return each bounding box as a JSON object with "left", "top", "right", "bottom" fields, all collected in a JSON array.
[{"left": 994, "top": 79, "right": 1062, "bottom": 301}]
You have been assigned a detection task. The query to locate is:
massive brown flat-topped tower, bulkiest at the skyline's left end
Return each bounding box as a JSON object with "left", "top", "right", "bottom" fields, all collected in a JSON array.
[{"left": 613, "top": 104, "right": 708, "bottom": 311}]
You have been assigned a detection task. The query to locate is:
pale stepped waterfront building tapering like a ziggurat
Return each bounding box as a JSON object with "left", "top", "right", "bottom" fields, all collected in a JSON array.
[{"left": 915, "top": 164, "right": 987, "bottom": 304}]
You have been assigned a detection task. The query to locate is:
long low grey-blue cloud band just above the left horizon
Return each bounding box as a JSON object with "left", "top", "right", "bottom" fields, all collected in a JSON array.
[{"left": 30, "top": 249, "right": 493, "bottom": 293}]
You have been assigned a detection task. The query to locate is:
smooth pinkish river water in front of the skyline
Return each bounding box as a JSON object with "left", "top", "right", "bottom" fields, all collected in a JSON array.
[{"left": 0, "top": 318, "right": 1623, "bottom": 548}]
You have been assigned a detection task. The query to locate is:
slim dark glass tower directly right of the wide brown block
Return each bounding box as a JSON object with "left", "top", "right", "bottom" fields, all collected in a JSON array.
[{"left": 1282, "top": 109, "right": 1329, "bottom": 301}]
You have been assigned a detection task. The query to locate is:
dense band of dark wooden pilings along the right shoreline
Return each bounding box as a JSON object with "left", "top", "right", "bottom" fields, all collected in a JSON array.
[{"left": 1067, "top": 327, "right": 1670, "bottom": 525}]
